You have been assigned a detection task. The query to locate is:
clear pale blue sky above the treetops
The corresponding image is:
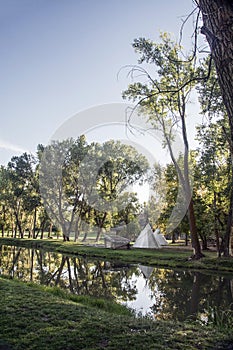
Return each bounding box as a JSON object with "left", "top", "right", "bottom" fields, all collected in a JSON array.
[{"left": 0, "top": 0, "right": 200, "bottom": 164}]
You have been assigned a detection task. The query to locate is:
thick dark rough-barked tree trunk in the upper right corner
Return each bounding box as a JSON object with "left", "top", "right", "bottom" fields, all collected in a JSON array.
[{"left": 198, "top": 0, "right": 233, "bottom": 256}]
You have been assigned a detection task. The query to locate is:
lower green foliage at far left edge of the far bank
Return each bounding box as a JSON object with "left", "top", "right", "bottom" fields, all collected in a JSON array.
[{"left": 0, "top": 153, "right": 41, "bottom": 237}]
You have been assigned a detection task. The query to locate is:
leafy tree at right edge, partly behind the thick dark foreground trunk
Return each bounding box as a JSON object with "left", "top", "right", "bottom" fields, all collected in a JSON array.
[{"left": 197, "top": 56, "right": 233, "bottom": 256}]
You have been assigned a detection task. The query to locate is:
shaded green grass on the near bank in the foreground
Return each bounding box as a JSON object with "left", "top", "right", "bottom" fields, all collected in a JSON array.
[{"left": 0, "top": 278, "right": 233, "bottom": 350}]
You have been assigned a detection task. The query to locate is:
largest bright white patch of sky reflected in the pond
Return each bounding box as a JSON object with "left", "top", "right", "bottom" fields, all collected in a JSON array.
[{"left": 122, "top": 266, "right": 161, "bottom": 316}]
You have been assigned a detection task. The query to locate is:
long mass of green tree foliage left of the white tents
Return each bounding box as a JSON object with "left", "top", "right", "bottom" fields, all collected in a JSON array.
[{"left": 0, "top": 135, "right": 148, "bottom": 240}]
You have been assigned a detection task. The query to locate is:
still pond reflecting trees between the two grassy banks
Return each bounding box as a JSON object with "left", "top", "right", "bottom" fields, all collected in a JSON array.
[{"left": 0, "top": 245, "right": 233, "bottom": 321}]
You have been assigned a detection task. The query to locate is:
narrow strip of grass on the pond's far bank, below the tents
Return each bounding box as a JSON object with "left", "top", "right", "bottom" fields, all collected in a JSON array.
[{"left": 0, "top": 238, "right": 233, "bottom": 273}]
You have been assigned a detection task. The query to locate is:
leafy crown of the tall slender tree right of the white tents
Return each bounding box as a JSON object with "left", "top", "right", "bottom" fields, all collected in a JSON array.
[{"left": 123, "top": 33, "right": 198, "bottom": 117}]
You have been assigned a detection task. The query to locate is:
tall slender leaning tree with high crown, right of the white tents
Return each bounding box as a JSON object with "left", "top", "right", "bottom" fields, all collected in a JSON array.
[{"left": 123, "top": 33, "right": 203, "bottom": 259}]
